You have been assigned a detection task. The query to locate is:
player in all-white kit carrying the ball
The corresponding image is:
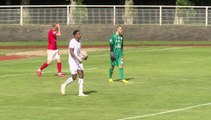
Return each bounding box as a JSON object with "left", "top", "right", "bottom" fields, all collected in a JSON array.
[{"left": 61, "top": 30, "right": 87, "bottom": 96}]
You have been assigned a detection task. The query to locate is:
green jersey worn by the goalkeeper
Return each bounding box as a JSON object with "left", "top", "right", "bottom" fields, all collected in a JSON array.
[{"left": 110, "top": 34, "right": 124, "bottom": 58}]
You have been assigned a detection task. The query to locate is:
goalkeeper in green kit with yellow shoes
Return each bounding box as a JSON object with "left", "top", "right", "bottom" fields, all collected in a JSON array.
[{"left": 109, "top": 26, "right": 128, "bottom": 83}]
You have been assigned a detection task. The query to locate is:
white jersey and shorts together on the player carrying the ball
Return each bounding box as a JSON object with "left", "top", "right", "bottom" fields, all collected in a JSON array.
[{"left": 69, "top": 38, "right": 83, "bottom": 74}]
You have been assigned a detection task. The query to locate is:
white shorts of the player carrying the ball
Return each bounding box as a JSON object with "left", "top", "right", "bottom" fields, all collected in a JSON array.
[{"left": 69, "top": 60, "right": 84, "bottom": 74}]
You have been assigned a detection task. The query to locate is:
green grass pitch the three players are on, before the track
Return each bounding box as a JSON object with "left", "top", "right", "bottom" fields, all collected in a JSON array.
[{"left": 0, "top": 42, "right": 211, "bottom": 120}]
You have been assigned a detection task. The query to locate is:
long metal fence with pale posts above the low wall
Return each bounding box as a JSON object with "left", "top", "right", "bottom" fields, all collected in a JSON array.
[{"left": 0, "top": 5, "right": 211, "bottom": 26}]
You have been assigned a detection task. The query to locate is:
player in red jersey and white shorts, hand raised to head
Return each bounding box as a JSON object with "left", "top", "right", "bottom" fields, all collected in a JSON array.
[{"left": 36, "top": 24, "right": 65, "bottom": 77}]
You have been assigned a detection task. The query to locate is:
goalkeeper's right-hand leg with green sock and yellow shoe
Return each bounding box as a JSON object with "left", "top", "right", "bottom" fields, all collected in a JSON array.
[{"left": 117, "top": 57, "right": 128, "bottom": 83}]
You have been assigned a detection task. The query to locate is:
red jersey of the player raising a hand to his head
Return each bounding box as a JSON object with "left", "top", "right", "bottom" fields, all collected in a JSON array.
[{"left": 48, "top": 29, "right": 57, "bottom": 50}]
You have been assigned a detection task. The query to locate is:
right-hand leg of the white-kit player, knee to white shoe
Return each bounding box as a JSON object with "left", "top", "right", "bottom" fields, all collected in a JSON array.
[{"left": 77, "top": 70, "right": 88, "bottom": 96}]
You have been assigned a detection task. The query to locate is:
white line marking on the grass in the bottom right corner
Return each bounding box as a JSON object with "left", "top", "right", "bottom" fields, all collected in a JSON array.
[{"left": 117, "top": 102, "right": 211, "bottom": 120}]
